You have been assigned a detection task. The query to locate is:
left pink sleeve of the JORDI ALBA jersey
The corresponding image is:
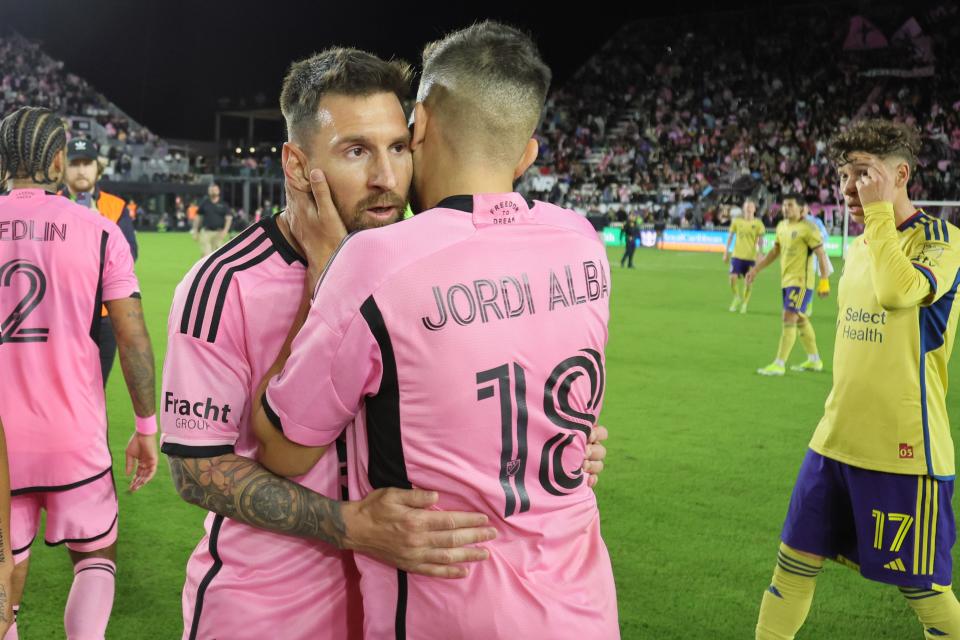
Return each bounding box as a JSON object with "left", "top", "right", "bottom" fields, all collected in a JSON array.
[{"left": 264, "top": 245, "right": 383, "bottom": 447}]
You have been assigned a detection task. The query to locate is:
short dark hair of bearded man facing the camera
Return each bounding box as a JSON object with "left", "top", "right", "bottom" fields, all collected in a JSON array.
[{"left": 280, "top": 47, "right": 413, "bottom": 141}]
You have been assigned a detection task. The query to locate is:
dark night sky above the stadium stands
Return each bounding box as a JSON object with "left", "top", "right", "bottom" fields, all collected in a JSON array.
[{"left": 0, "top": 0, "right": 796, "bottom": 140}]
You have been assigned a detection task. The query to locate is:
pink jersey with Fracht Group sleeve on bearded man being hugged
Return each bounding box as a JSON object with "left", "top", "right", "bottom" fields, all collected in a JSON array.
[{"left": 160, "top": 217, "right": 361, "bottom": 640}]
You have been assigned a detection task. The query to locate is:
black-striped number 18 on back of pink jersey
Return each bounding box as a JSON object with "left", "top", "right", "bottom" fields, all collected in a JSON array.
[{"left": 477, "top": 349, "right": 604, "bottom": 518}]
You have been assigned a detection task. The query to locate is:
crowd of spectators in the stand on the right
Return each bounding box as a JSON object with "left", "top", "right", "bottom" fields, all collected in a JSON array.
[{"left": 524, "top": 1, "right": 960, "bottom": 227}]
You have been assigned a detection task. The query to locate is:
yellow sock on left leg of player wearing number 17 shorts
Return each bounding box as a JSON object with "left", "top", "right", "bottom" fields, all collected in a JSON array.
[{"left": 756, "top": 543, "right": 823, "bottom": 640}]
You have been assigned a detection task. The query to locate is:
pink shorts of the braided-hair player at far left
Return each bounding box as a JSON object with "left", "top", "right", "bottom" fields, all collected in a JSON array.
[{"left": 10, "top": 469, "right": 118, "bottom": 562}]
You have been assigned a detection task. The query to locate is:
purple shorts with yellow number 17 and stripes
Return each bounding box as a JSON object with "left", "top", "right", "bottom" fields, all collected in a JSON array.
[{"left": 781, "top": 451, "right": 956, "bottom": 591}]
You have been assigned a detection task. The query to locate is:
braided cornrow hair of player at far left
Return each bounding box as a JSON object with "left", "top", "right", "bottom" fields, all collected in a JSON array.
[{"left": 0, "top": 107, "right": 67, "bottom": 184}]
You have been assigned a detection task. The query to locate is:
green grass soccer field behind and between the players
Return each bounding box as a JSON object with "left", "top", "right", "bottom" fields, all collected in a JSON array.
[{"left": 20, "top": 234, "right": 960, "bottom": 640}]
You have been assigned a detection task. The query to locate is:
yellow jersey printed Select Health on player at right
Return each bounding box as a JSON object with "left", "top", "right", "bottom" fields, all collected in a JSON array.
[{"left": 810, "top": 203, "right": 960, "bottom": 479}]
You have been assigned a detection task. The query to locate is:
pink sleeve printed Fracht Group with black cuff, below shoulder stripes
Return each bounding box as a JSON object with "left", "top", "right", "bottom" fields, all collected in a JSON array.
[{"left": 160, "top": 281, "right": 251, "bottom": 458}]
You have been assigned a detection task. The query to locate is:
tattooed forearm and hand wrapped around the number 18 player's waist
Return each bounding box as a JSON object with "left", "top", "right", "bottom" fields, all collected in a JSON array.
[{"left": 167, "top": 453, "right": 496, "bottom": 578}]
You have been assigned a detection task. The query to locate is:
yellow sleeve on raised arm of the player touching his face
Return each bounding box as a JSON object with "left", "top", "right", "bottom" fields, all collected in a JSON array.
[{"left": 863, "top": 202, "right": 960, "bottom": 309}]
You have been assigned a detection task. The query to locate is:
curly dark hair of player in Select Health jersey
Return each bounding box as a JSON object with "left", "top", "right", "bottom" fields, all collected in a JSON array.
[{"left": 827, "top": 118, "right": 920, "bottom": 173}]
